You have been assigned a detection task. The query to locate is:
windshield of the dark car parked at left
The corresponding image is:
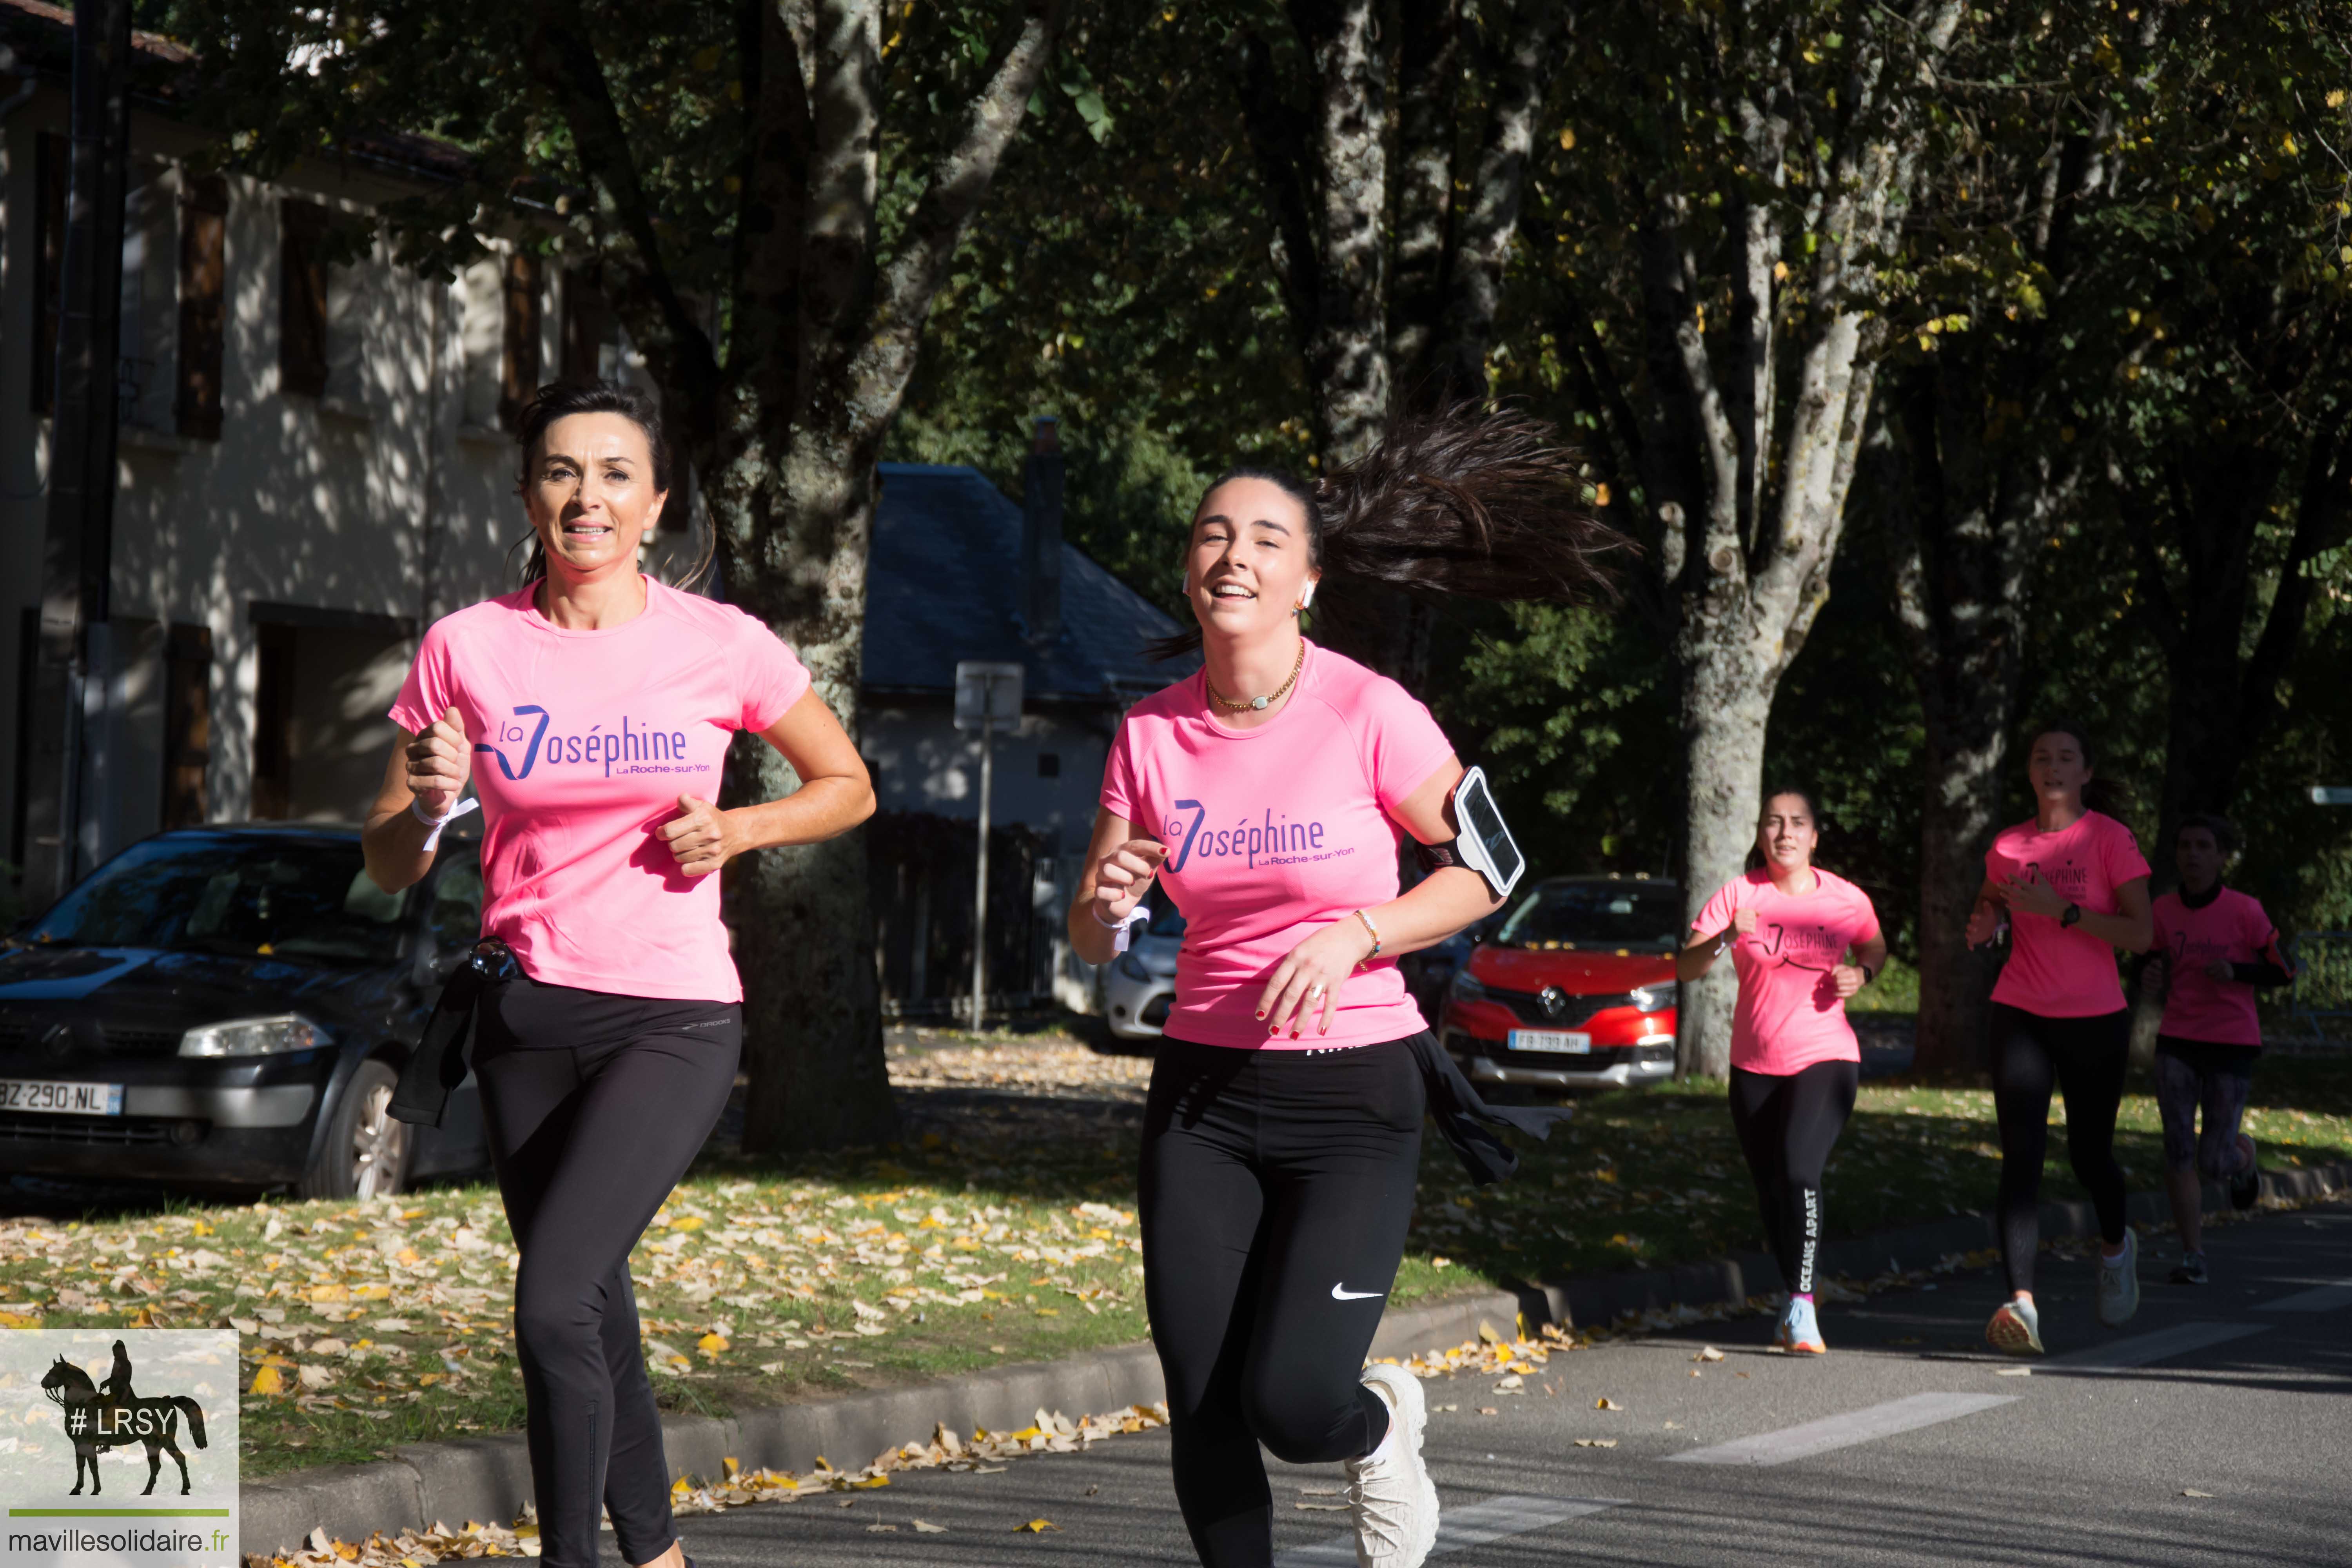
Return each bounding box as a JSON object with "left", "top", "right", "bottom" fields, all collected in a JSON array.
[{"left": 16, "top": 832, "right": 407, "bottom": 964}]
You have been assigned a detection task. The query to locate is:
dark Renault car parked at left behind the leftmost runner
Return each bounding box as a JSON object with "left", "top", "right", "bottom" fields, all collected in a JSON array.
[{"left": 0, "top": 823, "right": 487, "bottom": 1196}]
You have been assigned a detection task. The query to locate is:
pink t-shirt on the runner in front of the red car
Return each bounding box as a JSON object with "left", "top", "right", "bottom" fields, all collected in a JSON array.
[{"left": 1691, "top": 865, "right": 1879, "bottom": 1077}]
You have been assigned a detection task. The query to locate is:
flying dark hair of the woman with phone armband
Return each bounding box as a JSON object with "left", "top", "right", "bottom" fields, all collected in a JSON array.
[{"left": 1150, "top": 402, "right": 1632, "bottom": 658}]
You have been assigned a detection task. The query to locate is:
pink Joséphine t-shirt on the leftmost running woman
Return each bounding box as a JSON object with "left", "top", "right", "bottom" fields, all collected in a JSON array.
[{"left": 393, "top": 578, "right": 809, "bottom": 1002}]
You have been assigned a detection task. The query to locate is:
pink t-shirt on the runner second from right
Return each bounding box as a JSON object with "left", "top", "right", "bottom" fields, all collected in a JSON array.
[{"left": 1985, "top": 811, "right": 2147, "bottom": 1018}]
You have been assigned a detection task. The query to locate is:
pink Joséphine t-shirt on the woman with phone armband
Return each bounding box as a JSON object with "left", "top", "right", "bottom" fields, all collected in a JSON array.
[{"left": 1103, "top": 642, "right": 1454, "bottom": 1051}]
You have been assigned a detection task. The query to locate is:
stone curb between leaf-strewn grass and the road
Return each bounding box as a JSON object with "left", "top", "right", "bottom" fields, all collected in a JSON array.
[{"left": 238, "top": 1164, "right": 2352, "bottom": 1554}]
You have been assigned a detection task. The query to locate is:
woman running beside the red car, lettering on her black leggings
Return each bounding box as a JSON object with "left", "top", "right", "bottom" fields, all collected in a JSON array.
[{"left": 1675, "top": 790, "right": 1886, "bottom": 1356}]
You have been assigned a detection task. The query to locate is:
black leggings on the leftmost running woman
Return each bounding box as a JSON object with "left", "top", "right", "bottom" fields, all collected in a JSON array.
[{"left": 473, "top": 978, "right": 743, "bottom": 1568}]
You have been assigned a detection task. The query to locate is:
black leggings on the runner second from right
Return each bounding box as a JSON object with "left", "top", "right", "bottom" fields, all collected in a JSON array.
[{"left": 1992, "top": 1002, "right": 2131, "bottom": 1290}]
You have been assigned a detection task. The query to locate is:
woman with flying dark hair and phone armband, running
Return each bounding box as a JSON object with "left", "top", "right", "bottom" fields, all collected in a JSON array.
[{"left": 1070, "top": 411, "right": 1613, "bottom": 1568}]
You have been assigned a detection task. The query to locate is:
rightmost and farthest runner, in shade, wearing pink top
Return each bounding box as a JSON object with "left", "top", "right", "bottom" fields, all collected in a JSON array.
[{"left": 2147, "top": 816, "right": 2293, "bottom": 1286}]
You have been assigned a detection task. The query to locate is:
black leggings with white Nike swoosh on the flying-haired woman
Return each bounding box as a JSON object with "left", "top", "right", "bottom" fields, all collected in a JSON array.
[{"left": 1141, "top": 1039, "right": 1423, "bottom": 1568}]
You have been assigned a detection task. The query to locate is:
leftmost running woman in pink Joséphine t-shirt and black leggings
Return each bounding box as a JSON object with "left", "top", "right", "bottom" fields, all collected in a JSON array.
[{"left": 360, "top": 381, "right": 875, "bottom": 1568}]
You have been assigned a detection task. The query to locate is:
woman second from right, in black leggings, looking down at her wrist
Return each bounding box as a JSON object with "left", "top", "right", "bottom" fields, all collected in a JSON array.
[{"left": 1969, "top": 722, "right": 2154, "bottom": 1356}]
